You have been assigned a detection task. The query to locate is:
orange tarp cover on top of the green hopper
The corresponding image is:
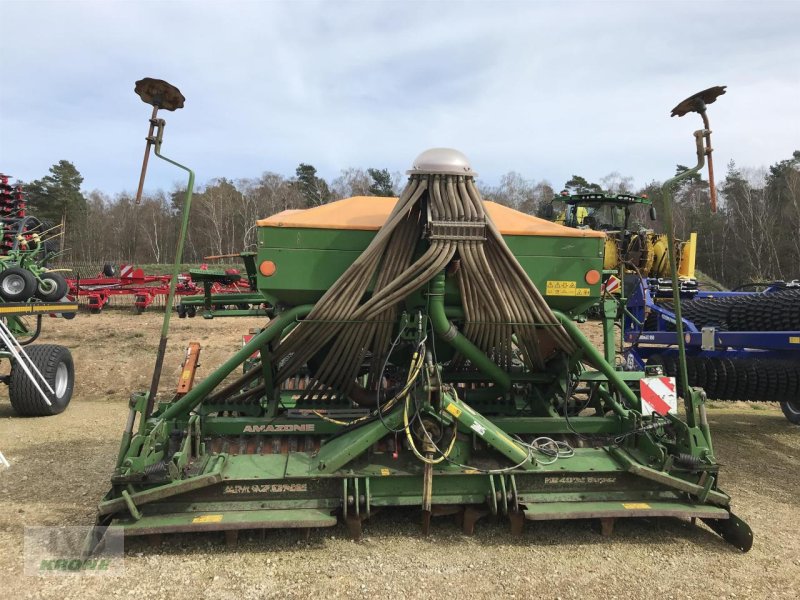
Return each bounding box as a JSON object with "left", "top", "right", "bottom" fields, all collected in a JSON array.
[{"left": 256, "top": 196, "right": 605, "bottom": 238}]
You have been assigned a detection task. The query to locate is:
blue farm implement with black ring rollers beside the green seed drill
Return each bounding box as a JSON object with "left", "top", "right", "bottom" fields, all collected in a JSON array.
[{"left": 624, "top": 279, "right": 800, "bottom": 425}]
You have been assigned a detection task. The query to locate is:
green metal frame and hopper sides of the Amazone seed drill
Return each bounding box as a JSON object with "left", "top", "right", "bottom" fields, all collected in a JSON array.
[{"left": 98, "top": 125, "right": 752, "bottom": 550}]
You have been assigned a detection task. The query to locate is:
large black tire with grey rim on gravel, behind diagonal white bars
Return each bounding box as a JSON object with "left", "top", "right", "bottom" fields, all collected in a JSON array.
[{"left": 8, "top": 344, "right": 75, "bottom": 417}]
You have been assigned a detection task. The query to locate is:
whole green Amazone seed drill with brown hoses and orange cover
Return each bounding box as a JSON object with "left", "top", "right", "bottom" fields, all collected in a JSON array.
[{"left": 87, "top": 79, "right": 752, "bottom": 551}]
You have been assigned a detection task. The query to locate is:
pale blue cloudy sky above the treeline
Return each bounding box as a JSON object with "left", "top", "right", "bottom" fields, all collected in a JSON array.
[{"left": 0, "top": 0, "right": 800, "bottom": 193}]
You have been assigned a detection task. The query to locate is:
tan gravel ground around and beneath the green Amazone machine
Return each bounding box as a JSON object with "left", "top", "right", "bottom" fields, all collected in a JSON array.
[{"left": 0, "top": 312, "right": 800, "bottom": 600}]
